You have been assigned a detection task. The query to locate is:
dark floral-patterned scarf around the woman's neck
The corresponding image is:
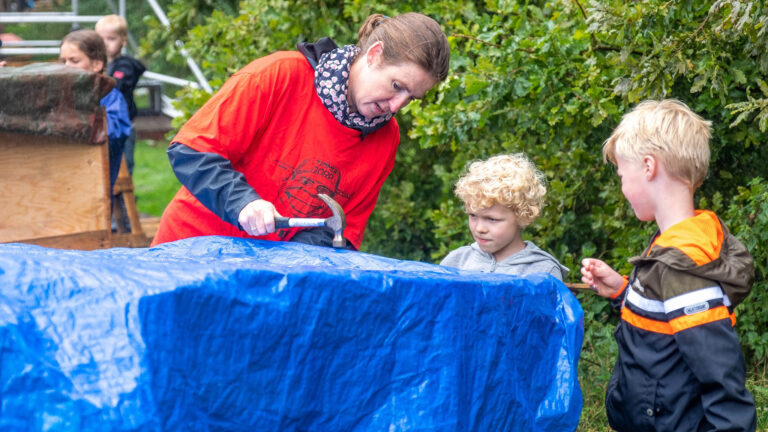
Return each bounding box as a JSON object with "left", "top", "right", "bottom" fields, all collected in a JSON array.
[{"left": 315, "top": 45, "right": 392, "bottom": 137}]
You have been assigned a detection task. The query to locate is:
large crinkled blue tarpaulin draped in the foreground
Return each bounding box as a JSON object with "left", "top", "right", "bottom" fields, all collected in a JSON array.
[{"left": 0, "top": 237, "right": 583, "bottom": 432}]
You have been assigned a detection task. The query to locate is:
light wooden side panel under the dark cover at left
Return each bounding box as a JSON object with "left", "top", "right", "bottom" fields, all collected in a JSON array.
[{"left": 0, "top": 132, "right": 110, "bottom": 242}]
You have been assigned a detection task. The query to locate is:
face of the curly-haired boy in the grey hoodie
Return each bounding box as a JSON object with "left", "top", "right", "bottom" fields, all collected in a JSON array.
[{"left": 467, "top": 204, "right": 525, "bottom": 261}]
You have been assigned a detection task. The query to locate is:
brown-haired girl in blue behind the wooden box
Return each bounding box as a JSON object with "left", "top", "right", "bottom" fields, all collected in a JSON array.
[{"left": 59, "top": 30, "right": 131, "bottom": 187}]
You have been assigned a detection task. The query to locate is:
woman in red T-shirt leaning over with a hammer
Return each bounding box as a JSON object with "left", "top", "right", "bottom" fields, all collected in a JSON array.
[{"left": 152, "top": 13, "right": 450, "bottom": 249}]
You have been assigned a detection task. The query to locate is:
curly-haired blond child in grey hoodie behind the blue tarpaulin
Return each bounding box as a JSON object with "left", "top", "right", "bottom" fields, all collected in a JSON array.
[{"left": 440, "top": 153, "right": 568, "bottom": 281}]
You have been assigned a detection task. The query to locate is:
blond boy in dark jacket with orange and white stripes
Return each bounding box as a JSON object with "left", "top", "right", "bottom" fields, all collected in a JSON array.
[{"left": 581, "top": 100, "right": 756, "bottom": 431}]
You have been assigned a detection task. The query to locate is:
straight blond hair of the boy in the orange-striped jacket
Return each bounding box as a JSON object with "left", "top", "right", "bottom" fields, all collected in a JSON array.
[{"left": 603, "top": 99, "right": 712, "bottom": 188}]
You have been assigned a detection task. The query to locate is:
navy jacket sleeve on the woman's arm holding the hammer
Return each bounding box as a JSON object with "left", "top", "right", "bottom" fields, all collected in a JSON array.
[{"left": 168, "top": 142, "right": 261, "bottom": 229}]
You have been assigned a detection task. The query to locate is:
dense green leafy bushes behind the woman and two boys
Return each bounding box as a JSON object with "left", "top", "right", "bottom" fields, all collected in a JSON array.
[{"left": 142, "top": 0, "right": 768, "bottom": 430}]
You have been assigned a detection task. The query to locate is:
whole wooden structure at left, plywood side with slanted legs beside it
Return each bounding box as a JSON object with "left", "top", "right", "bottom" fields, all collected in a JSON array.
[{"left": 0, "top": 131, "right": 150, "bottom": 250}]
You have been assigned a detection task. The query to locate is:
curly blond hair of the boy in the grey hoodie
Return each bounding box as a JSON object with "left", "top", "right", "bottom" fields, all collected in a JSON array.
[{"left": 455, "top": 153, "right": 547, "bottom": 227}]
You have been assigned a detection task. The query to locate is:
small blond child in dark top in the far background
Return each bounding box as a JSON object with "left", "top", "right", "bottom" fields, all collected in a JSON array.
[{"left": 95, "top": 15, "right": 146, "bottom": 174}]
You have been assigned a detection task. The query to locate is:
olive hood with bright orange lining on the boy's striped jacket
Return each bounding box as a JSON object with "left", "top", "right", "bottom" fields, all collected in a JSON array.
[{"left": 630, "top": 210, "right": 755, "bottom": 307}]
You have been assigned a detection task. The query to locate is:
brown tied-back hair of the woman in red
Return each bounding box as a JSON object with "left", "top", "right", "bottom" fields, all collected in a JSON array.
[{"left": 357, "top": 12, "right": 451, "bottom": 81}]
